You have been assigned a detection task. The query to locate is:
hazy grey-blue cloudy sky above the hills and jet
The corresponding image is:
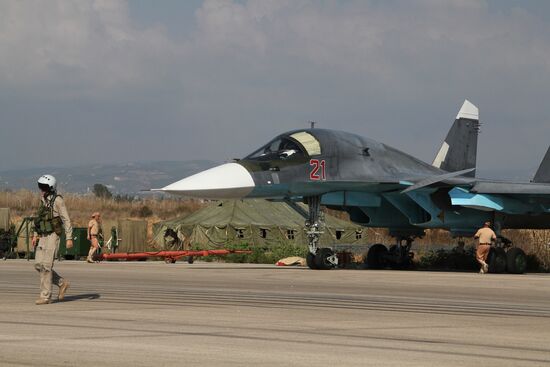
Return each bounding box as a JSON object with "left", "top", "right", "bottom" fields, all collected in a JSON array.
[{"left": 0, "top": 0, "right": 550, "bottom": 178}]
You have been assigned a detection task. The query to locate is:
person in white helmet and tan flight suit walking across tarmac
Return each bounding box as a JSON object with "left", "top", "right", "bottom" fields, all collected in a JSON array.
[{"left": 32, "top": 175, "right": 73, "bottom": 305}]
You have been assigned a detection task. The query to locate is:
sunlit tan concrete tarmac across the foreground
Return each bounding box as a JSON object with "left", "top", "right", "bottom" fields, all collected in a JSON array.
[{"left": 0, "top": 260, "right": 550, "bottom": 367}]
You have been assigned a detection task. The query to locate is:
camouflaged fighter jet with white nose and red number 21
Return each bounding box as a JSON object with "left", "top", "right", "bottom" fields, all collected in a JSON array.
[{"left": 158, "top": 100, "right": 550, "bottom": 272}]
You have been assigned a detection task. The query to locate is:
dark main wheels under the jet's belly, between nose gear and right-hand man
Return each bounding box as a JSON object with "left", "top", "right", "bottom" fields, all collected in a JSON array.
[{"left": 365, "top": 237, "right": 413, "bottom": 269}]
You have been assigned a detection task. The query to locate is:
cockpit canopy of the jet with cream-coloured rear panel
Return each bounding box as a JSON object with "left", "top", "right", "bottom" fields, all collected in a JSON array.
[{"left": 244, "top": 131, "right": 321, "bottom": 161}]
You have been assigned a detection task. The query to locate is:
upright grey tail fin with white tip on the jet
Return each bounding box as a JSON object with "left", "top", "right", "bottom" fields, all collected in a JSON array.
[{"left": 432, "top": 100, "right": 479, "bottom": 177}]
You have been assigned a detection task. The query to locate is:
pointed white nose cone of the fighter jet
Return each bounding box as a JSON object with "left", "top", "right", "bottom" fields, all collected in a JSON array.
[{"left": 153, "top": 163, "right": 255, "bottom": 199}]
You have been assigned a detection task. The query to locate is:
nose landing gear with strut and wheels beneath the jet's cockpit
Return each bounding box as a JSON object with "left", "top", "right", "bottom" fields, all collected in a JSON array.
[{"left": 304, "top": 196, "right": 338, "bottom": 270}]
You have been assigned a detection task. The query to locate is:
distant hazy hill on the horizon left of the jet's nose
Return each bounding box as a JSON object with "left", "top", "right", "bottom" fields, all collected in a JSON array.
[{"left": 0, "top": 160, "right": 218, "bottom": 195}]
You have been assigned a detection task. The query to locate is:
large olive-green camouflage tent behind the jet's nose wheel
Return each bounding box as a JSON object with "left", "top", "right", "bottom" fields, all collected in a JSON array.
[{"left": 153, "top": 199, "right": 367, "bottom": 249}]
